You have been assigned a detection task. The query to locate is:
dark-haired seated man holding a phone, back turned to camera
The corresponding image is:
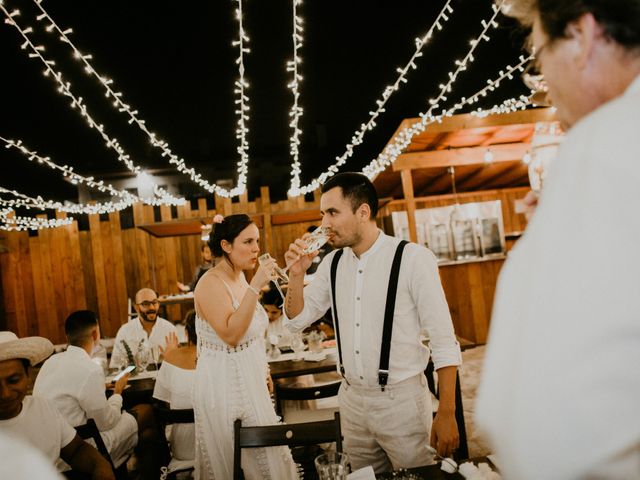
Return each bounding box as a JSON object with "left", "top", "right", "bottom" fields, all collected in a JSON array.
[{"left": 33, "top": 310, "right": 166, "bottom": 479}]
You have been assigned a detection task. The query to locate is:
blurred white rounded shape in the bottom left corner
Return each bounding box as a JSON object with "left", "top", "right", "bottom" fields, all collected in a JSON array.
[{"left": 0, "top": 430, "right": 64, "bottom": 480}]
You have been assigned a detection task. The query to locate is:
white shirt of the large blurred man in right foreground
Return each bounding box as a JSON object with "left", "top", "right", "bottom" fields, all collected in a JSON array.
[{"left": 476, "top": 77, "right": 640, "bottom": 480}]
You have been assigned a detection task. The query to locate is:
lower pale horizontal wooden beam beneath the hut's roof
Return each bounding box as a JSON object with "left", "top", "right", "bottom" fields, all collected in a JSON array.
[{"left": 393, "top": 143, "right": 531, "bottom": 172}]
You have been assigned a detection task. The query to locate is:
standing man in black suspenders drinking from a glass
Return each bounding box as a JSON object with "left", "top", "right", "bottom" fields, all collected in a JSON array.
[{"left": 285, "top": 173, "right": 460, "bottom": 473}]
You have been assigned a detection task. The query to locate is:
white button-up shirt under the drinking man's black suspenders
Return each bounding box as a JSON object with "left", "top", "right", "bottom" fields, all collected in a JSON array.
[{"left": 284, "top": 231, "right": 461, "bottom": 387}]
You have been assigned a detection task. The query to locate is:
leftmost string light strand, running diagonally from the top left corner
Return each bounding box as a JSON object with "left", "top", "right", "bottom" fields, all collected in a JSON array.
[{"left": 0, "top": 3, "right": 185, "bottom": 205}]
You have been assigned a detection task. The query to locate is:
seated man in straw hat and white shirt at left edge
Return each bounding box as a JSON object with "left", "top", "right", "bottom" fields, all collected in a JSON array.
[{"left": 0, "top": 332, "right": 115, "bottom": 480}]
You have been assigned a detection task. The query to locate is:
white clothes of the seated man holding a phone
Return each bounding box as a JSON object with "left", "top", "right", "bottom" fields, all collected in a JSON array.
[{"left": 33, "top": 345, "right": 138, "bottom": 467}]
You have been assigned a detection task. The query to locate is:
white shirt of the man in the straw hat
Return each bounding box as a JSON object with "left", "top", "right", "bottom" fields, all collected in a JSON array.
[{"left": 0, "top": 395, "right": 76, "bottom": 470}]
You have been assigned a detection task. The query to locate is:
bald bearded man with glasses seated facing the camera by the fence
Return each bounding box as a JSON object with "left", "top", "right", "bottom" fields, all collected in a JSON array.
[{"left": 109, "top": 288, "right": 177, "bottom": 368}]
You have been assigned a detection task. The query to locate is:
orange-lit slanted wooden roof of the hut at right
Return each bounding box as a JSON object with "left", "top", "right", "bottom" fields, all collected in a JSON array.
[{"left": 374, "top": 108, "right": 555, "bottom": 198}]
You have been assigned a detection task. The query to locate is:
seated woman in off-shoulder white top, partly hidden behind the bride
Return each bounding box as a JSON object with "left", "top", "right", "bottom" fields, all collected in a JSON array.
[{"left": 153, "top": 310, "right": 198, "bottom": 472}]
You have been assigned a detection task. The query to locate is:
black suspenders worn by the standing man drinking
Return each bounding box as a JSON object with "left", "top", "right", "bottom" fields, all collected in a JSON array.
[{"left": 331, "top": 240, "right": 409, "bottom": 392}]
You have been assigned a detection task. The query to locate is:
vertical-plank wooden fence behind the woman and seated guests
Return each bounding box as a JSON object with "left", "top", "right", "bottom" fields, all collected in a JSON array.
[{"left": 0, "top": 187, "right": 320, "bottom": 343}]
